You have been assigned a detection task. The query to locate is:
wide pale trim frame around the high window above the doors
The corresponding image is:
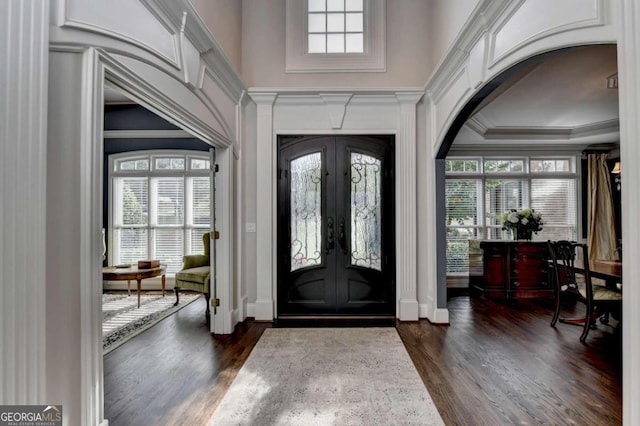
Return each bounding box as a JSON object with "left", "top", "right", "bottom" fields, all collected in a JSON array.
[{"left": 285, "top": 0, "right": 386, "bottom": 73}]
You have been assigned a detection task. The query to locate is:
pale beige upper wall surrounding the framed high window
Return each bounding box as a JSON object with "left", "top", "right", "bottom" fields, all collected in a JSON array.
[{"left": 242, "top": 0, "right": 434, "bottom": 87}]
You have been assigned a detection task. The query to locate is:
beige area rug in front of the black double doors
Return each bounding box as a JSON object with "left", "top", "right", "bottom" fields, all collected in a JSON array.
[{"left": 209, "top": 328, "right": 444, "bottom": 426}]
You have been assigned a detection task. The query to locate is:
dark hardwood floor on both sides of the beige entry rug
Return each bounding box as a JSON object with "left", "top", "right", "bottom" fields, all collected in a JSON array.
[{"left": 104, "top": 296, "right": 622, "bottom": 426}]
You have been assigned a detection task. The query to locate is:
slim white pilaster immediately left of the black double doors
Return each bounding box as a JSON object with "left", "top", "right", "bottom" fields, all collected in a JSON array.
[{"left": 251, "top": 93, "right": 277, "bottom": 321}]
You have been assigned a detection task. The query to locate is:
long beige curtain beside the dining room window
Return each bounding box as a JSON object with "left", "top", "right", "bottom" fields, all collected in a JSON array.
[{"left": 587, "top": 154, "right": 618, "bottom": 260}]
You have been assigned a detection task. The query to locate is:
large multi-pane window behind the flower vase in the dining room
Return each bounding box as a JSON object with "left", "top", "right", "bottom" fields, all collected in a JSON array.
[{"left": 445, "top": 157, "right": 579, "bottom": 275}]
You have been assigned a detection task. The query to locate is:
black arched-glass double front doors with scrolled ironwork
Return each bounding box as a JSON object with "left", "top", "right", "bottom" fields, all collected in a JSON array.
[{"left": 277, "top": 136, "right": 395, "bottom": 316}]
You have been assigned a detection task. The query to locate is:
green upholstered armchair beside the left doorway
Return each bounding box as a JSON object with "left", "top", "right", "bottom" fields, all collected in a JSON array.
[{"left": 174, "top": 232, "right": 211, "bottom": 324}]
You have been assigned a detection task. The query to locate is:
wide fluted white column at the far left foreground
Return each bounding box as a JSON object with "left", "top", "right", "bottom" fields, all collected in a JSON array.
[{"left": 0, "top": 0, "right": 49, "bottom": 404}]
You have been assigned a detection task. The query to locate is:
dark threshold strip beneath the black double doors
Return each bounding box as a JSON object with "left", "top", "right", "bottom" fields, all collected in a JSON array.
[{"left": 273, "top": 315, "right": 396, "bottom": 328}]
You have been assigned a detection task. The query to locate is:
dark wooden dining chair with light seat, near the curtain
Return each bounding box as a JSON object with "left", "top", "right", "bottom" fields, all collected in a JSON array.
[{"left": 548, "top": 241, "right": 622, "bottom": 342}]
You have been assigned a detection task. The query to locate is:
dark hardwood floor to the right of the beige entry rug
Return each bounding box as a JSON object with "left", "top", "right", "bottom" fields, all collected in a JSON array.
[{"left": 398, "top": 297, "right": 622, "bottom": 425}]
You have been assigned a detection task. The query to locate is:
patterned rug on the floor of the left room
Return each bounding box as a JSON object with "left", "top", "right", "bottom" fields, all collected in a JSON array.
[{"left": 102, "top": 292, "right": 200, "bottom": 355}]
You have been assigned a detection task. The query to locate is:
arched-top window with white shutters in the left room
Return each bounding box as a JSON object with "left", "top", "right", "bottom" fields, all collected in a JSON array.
[{"left": 109, "top": 151, "right": 211, "bottom": 276}]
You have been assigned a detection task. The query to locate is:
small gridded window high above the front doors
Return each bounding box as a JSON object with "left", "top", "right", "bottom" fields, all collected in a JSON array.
[{"left": 307, "top": 0, "right": 364, "bottom": 53}]
